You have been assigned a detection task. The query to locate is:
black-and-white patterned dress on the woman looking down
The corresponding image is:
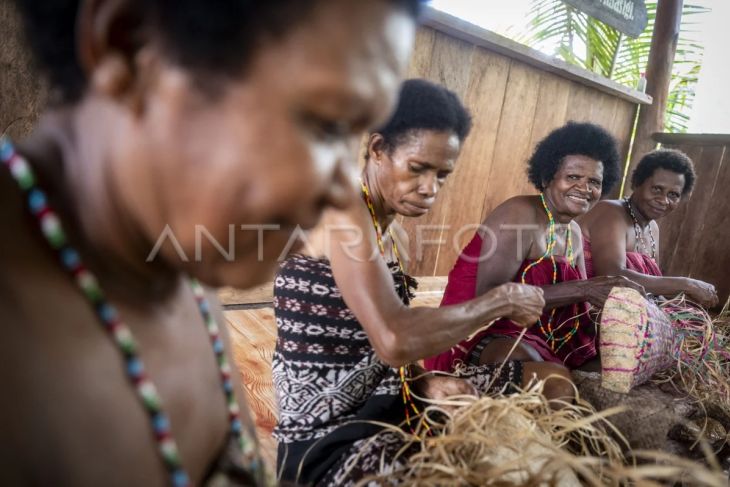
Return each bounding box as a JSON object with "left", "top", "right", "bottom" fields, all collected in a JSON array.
[{"left": 273, "top": 255, "right": 519, "bottom": 486}]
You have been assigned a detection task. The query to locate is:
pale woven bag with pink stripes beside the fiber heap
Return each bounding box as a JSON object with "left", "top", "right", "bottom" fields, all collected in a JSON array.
[{"left": 599, "top": 287, "right": 674, "bottom": 393}]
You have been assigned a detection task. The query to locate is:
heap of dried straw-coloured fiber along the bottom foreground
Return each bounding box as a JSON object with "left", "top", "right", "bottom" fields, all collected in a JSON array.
[{"left": 358, "top": 382, "right": 727, "bottom": 486}]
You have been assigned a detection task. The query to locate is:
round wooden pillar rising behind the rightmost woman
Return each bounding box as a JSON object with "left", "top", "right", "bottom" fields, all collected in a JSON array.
[{"left": 625, "top": 0, "right": 683, "bottom": 192}]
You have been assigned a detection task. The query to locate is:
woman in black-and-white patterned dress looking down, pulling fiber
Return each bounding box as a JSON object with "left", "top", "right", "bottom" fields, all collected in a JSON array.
[{"left": 273, "top": 80, "right": 544, "bottom": 486}]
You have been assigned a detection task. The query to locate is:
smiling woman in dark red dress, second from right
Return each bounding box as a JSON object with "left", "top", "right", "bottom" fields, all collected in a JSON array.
[{"left": 426, "top": 122, "right": 638, "bottom": 400}]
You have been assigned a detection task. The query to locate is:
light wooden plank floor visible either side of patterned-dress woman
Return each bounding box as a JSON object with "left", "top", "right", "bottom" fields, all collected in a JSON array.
[{"left": 218, "top": 277, "right": 446, "bottom": 472}]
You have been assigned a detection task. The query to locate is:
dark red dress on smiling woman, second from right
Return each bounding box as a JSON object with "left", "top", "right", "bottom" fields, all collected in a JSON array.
[{"left": 424, "top": 234, "right": 597, "bottom": 371}]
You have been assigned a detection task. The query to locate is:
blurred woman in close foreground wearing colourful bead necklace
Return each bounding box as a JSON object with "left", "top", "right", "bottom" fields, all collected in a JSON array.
[{"left": 0, "top": 0, "right": 418, "bottom": 487}]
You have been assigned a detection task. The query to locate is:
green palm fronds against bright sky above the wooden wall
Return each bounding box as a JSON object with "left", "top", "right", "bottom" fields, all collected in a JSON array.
[{"left": 515, "top": 0, "right": 709, "bottom": 132}]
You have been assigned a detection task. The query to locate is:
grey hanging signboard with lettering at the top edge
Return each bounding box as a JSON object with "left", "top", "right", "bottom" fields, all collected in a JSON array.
[{"left": 563, "top": 0, "right": 648, "bottom": 37}]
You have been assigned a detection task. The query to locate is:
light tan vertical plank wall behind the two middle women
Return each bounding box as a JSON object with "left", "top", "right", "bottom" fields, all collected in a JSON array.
[{"left": 401, "top": 27, "right": 636, "bottom": 276}]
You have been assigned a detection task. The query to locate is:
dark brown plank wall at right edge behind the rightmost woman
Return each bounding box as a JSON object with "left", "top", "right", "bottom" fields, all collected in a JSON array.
[{"left": 655, "top": 134, "right": 730, "bottom": 305}]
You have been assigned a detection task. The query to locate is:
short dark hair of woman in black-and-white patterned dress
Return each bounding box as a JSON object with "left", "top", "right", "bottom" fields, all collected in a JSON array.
[{"left": 373, "top": 79, "right": 471, "bottom": 152}]
